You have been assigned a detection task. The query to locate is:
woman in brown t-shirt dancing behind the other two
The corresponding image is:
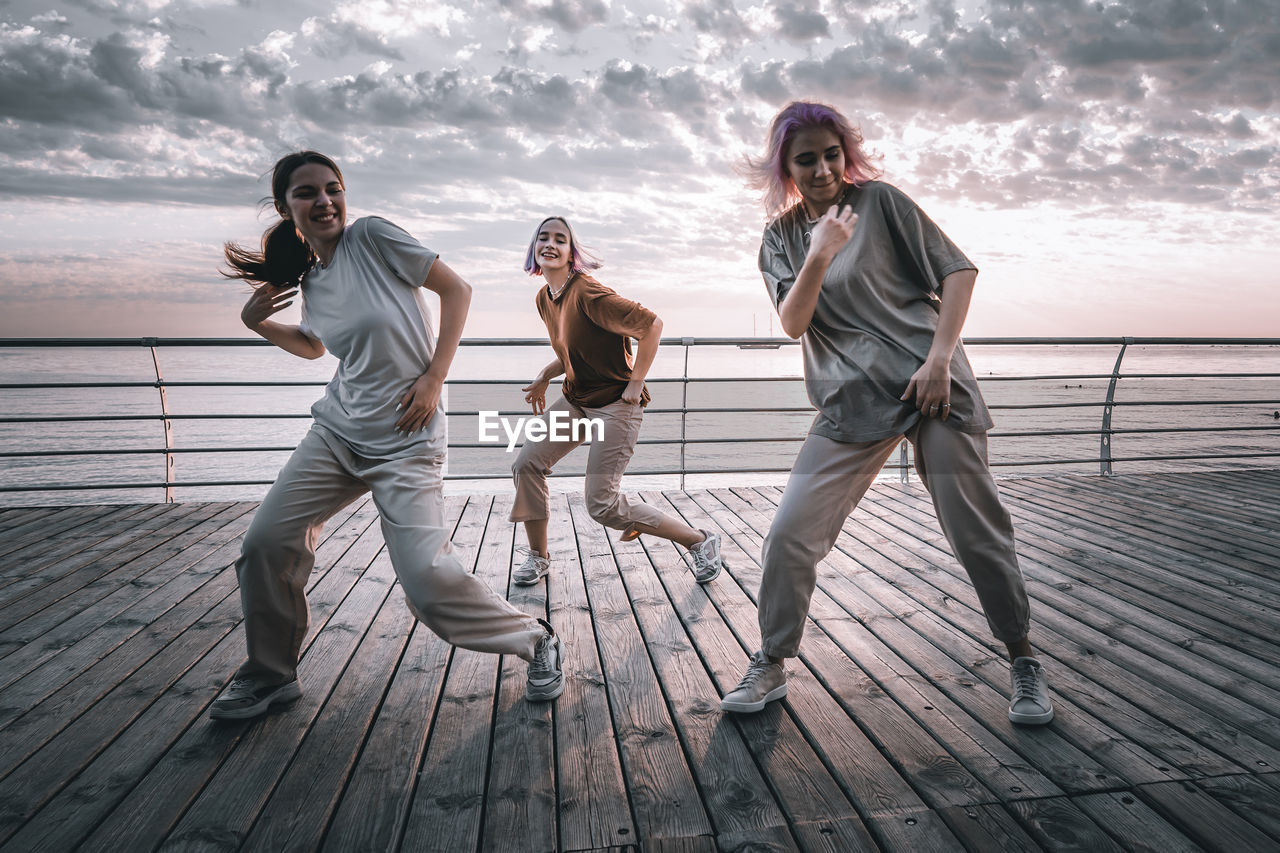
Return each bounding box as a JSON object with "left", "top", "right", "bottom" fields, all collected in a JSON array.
[{"left": 511, "top": 216, "right": 723, "bottom": 585}]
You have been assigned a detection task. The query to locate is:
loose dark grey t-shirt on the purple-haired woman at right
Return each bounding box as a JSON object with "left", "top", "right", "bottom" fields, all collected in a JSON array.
[{"left": 759, "top": 181, "right": 992, "bottom": 442}]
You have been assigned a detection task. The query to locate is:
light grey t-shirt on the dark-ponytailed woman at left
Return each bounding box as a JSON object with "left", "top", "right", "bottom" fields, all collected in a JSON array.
[{"left": 300, "top": 216, "right": 448, "bottom": 459}]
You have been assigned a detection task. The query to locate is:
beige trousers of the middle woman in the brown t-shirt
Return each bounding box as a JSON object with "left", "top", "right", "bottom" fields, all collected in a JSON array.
[{"left": 511, "top": 397, "right": 667, "bottom": 530}]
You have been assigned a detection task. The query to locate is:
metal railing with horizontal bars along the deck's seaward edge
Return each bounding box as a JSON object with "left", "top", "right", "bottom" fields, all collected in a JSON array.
[{"left": 0, "top": 337, "right": 1280, "bottom": 501}]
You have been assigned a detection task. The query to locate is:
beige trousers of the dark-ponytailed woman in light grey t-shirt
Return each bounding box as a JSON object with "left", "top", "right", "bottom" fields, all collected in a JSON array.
[{"left": 236, "top": 427, "right": 544, "bottom": 681}]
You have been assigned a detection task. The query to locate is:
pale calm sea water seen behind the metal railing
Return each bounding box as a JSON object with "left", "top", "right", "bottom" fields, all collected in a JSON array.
[{"left": 0, "top": 343, "right": 1280, "bottom": 506}]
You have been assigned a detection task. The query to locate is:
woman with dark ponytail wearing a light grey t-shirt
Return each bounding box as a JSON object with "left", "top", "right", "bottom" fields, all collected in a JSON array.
[{"left": 210, "top": 151, "right": 564, "bottom": 720}]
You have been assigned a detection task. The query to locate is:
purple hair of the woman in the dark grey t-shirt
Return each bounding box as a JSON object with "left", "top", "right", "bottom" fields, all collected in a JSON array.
[{"left": 746, "top": 101, "right": 881, "bottom": 218}]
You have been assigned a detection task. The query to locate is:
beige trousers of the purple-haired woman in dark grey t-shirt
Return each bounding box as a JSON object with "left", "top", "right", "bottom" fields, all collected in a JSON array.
[{"left": 759, "top": 418, "right": 1030, "bottom": 657}]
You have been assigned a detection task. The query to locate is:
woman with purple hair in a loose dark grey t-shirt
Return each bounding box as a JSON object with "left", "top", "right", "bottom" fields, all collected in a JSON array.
[{"left": 721, "top": 102, "right": 1053, "bottom": 725}]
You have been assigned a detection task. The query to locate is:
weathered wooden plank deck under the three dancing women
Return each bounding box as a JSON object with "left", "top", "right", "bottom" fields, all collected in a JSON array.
[{"left": 0, "top": 470, "right": 1280, "bottom": 853}]
